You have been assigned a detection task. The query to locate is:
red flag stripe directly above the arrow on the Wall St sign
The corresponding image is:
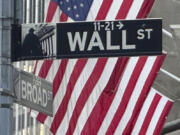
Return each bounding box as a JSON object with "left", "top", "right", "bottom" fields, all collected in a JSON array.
[{"left": 116, "top": 0, "right": 133, "bottom": 19}]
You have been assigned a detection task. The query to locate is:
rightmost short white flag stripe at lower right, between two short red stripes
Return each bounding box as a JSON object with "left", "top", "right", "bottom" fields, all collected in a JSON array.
[{"left": 146, "top": 89, "right": 169, "bottom": 135}]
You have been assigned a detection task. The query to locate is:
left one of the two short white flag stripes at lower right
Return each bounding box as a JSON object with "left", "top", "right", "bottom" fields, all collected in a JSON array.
[{"left": 132, "top": 91, "right": 156, "bottom": 135}]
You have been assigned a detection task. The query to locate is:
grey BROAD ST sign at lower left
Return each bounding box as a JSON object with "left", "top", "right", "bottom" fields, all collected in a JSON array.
[{"left": 14, "top": 69, "right": 53, "bottom": 116}]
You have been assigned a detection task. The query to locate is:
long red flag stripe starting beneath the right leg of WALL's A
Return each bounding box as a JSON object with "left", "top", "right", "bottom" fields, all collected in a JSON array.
[{"left": 66, "top": 58, "right": 107, "bottom": 135}]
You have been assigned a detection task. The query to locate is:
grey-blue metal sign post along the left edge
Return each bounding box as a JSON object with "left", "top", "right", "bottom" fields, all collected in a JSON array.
[{"left": 0, "top": 0, "right": 14, "bottom": 135}]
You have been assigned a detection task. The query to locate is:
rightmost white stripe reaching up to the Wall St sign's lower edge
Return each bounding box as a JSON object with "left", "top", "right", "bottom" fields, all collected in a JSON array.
[{"left": 115, "top": 56, "right": 156, "bottom": 134}]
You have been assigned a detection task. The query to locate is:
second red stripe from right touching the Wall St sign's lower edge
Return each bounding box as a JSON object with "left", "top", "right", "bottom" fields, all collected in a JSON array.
[{"left": 106, "top": 57, "right": 147, "bottom": 135}]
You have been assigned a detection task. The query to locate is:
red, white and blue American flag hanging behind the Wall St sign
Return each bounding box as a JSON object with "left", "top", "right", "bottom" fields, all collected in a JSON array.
[{"left": 31, "top": 0, "right": 172, "bottom": 135}]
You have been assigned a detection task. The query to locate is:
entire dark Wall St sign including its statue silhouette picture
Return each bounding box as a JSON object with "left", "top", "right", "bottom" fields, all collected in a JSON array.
[{"left": 12, "top": 19, "right": 162, "bottom": 61}]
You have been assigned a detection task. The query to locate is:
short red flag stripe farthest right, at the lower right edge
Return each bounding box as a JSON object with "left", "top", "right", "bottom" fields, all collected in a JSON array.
[{"left": 153, "top": 101, "right": 173, "bottom": 135}]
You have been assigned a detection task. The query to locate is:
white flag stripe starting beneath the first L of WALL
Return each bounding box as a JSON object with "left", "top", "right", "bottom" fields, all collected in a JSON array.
[{"left": 71, "top": 58, "right": 117, "bottom": 135}]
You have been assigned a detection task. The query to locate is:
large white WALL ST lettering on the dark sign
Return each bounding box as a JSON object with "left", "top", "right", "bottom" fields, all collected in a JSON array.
[{"left": 67, "top": 29, "right": 141, "bottom": 52}]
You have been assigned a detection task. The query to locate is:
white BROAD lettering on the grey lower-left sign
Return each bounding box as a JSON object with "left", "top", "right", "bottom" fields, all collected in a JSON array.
[{"left": 21, "top": 80, "right": 50, "bottom": 107}]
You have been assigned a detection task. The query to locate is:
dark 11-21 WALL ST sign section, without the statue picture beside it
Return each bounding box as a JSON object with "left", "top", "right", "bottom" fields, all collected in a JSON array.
[{"left": 57, "top": 19, "right": 162, "bottom": 58}]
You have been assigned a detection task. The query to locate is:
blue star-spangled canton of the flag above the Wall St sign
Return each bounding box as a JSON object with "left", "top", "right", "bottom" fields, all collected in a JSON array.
[{"left": 57, "top": 0, "right": 93, "bottom": 21}]
